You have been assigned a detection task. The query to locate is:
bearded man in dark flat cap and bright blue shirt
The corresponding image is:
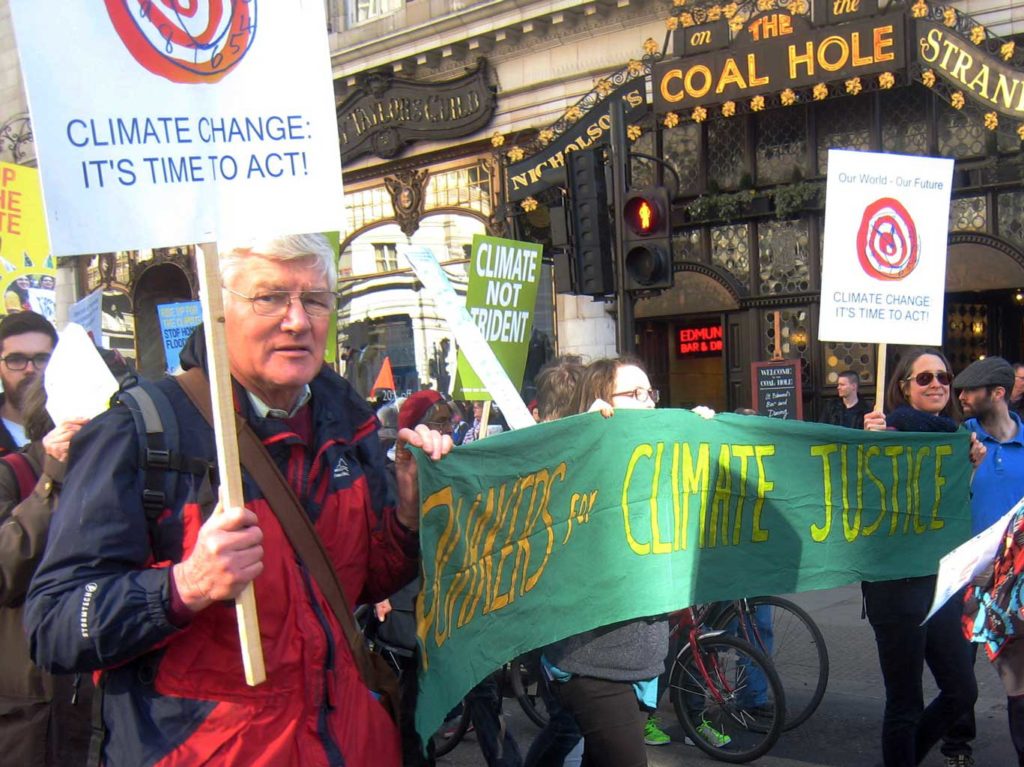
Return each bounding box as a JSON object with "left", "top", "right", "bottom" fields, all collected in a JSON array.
[{"left": 942, "top": 356, "right": 1024, "bottom": 765}]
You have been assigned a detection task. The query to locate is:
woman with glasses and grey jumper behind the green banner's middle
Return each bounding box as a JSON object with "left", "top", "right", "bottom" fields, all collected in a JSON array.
[{"left": 542, "top": 357, "right": 669, "bottom": 767}]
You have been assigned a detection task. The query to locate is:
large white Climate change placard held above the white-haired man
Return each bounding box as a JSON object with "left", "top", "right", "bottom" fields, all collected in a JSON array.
[{"left": 11, "top": 0, "right": 342, "bottom": 256}]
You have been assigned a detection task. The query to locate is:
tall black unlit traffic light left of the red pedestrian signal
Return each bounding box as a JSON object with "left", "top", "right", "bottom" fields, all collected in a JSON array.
[{"left": 567, "top": 150, "right": 615, "bottom": 296}]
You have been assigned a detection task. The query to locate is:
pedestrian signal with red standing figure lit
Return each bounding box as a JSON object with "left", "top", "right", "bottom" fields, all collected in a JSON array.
[{"left": 622, "top": 186, "right": 672, "bottom": 290}]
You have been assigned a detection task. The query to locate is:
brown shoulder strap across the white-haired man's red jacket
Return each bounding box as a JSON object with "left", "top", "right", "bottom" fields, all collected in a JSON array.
[{"left": 175, "top": 368, "right": 376, "bottom": 690}]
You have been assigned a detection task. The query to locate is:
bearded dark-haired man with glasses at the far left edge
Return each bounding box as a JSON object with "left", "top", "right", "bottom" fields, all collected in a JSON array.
[{"left": 0, "top": 311, "right": 57, "bottom": 455}]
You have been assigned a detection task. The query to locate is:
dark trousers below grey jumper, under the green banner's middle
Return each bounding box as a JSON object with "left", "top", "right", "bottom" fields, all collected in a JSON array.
[{"left": 552, "top": 676, "right": 647, "bottom": 767}]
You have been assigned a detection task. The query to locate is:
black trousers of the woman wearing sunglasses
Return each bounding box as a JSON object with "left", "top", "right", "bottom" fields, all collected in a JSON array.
[{"left": 862, "top": 576, "right": 978, "bottom": 767}]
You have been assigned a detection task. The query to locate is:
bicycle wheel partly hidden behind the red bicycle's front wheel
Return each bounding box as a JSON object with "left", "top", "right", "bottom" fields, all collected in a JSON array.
[{"left": 714, "top": 596, "right": 828, "bottom": 730}]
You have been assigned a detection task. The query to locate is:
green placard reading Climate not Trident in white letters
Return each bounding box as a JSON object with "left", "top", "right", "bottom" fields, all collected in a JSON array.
[{"left": 455, "top": 235, "right": 544, "bottom": 399}]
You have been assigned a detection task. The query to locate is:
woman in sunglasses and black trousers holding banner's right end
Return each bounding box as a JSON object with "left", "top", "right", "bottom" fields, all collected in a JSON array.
[{"left": 861, "top": 349, "right": 983, "bottom": 767}]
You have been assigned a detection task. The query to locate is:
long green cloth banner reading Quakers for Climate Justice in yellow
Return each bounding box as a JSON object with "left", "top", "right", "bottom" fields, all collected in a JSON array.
[{"left": 417, "top": 410, "right": 971, "bottom": 732}]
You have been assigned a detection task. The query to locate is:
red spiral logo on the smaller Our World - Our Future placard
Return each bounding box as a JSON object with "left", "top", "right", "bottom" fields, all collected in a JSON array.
[{"left": 857, "top": 197, "right": 921, "bottom": 280}]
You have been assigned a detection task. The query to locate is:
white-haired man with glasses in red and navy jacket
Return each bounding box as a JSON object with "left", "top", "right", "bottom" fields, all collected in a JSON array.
[{"left": 25, "top": 233, "right": 452, "bottom": 767}]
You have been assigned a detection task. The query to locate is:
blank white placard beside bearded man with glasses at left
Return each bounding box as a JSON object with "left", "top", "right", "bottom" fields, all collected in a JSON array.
[{"left": 43, "top": 323, "right": 118, "bottom": 424}]
